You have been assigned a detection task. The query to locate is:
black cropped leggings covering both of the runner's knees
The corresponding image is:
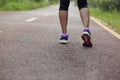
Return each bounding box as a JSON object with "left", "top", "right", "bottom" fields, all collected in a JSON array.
[{"left": 59, "top": 0, "right": 87, "bottom": 11}]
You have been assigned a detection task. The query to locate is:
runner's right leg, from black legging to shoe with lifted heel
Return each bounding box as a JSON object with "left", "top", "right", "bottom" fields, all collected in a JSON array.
[{"left": 78, "top": 0, "right": 92, "bottom": 47}]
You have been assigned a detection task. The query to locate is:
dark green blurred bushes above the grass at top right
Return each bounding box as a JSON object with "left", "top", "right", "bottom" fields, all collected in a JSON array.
[{"left": 88, "top": 0, "right": 120, "bottom": 12}]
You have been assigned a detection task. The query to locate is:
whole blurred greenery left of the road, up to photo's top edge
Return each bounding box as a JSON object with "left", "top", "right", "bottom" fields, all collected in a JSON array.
[{"left": 0, "top": 0, "right": 58, "bottom": 11}]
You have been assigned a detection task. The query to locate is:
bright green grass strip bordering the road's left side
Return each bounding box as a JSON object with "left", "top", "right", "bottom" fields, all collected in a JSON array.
[{"left": 0, "top": 1, "right": 49, "bottom": 11}]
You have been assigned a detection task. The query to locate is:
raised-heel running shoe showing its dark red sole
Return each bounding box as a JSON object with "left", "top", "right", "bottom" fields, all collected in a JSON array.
[{"left": 81, "top": 31, "right": 93, "bottom": 47}]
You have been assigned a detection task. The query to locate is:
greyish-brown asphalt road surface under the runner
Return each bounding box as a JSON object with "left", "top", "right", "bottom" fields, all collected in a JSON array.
[{"left": 0, "top": 6, "right": 120, "bottom": 80}]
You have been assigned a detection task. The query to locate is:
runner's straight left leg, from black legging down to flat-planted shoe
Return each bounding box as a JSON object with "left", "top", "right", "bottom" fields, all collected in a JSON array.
[{"left": 59, "top": 0, "right": 70, "bottom": 44}]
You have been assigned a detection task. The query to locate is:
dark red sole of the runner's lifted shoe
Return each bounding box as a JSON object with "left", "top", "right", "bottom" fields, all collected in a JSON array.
[{"left": 82, "top": 34, "right": 93, "bottom": 47}]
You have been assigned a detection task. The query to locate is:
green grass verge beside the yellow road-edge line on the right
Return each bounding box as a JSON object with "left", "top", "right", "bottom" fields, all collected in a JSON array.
[{"left": 90, "top": 8, "right": 120, "bottom": 33}]
